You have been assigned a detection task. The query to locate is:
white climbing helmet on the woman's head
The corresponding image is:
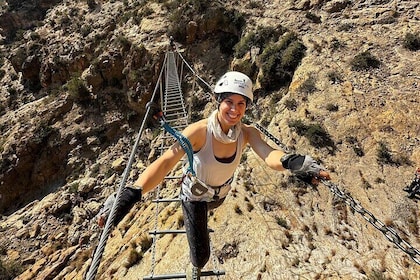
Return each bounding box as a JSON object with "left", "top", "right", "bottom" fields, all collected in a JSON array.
[{"left": 214, "top": 71, "right": 254, "bottom": 102}]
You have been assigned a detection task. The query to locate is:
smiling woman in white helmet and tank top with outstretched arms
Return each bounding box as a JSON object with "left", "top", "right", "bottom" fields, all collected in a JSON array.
[{"left": 98, "top": 71, "right": 330, "bottom": 279}]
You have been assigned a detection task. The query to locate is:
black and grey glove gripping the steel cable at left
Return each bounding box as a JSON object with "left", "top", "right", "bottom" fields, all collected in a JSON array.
[{"left": 98, "top": 187, "right": 142, "bottom": 227}]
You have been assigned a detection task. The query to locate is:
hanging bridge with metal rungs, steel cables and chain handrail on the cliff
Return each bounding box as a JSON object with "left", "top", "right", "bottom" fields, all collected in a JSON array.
[{"left": 85, "top": 37, "right": 420, "bottom": 280}]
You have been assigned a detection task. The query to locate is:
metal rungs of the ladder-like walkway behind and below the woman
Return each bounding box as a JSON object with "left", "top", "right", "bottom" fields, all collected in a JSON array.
[{"left": 143, "top": 51, "right": 225, "bottom": 280}]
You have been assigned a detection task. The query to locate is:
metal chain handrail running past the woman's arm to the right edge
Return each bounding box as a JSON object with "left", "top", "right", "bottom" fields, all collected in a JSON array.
[{"left": 254, "top": 123, "right": 420, "bottom": 264}]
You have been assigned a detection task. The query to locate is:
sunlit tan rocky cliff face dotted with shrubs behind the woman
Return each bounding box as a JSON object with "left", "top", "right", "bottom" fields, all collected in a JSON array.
[{"left": 0, "top": 0, "right": 420, "bottom": 279}]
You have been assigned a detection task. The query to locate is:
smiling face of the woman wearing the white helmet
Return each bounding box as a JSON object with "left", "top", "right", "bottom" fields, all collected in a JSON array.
[{"left": 219, "top": 94, "right": 246, "bottom": 127}]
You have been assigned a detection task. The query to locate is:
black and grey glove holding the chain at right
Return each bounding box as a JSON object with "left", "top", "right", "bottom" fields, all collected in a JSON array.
[{"left": 281, "top": 154, "right": 324, "bottom": 184}]
